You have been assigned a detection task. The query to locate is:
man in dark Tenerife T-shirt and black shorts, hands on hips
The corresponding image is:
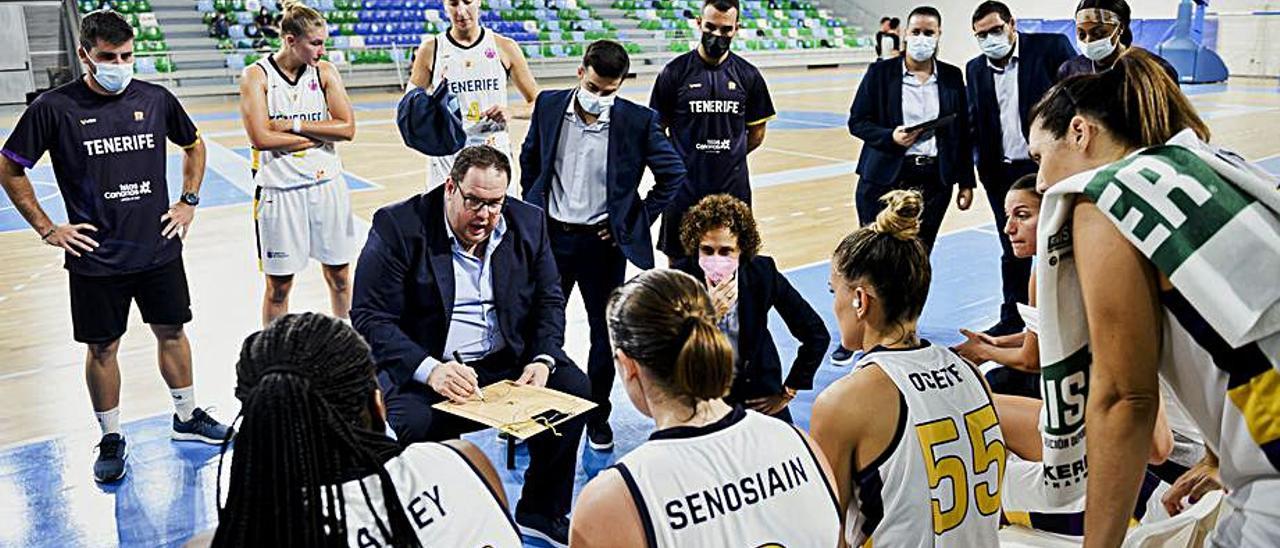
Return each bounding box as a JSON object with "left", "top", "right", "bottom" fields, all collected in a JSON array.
[{"left": 0, "top": 10, "right": 230, "bottom": 481}]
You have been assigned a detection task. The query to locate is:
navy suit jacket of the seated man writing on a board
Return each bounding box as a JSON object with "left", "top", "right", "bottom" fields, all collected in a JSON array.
[{"left": 351, "top": 184, "right": 572, "bottom": 385}]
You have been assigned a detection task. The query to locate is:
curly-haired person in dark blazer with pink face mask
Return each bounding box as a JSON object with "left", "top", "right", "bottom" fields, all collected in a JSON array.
[{"left": 672, "top": 195, "right": 831, "bottom": 423}]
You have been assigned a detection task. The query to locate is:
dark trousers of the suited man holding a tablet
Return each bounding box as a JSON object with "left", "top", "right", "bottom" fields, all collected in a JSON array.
[{"left": 854, "top": 163, "right": 951, "bottom": 250}]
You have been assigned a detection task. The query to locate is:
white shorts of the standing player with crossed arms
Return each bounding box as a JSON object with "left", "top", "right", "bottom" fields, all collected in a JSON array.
[{"left": 253, "top": 175, "right": 357, "bottom": 275}]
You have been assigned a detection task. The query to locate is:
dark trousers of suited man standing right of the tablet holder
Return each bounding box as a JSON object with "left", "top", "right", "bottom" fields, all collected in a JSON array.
[{"left": 982, "top": 160, "right": 1038, "bottom": 326}]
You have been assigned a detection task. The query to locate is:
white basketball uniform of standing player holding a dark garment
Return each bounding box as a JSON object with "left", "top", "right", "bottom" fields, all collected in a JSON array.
[{"left": 428, "top": 28, "right": 516, "bottom": 189}]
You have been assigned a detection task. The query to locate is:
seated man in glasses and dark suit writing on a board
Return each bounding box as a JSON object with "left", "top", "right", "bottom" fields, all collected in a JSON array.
[{"left": 351, "top": 146, "right": 590, "bottom": 545}]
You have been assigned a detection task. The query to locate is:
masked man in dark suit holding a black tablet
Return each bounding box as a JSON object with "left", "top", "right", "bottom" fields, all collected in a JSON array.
[{"left": 849, "top": 6, "right": 977, "bottom": 247}]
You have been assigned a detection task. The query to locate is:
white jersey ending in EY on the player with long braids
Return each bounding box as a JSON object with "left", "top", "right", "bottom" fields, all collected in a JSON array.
[{"left": 342, "top": 443, "right": 521, "bottom": 548}]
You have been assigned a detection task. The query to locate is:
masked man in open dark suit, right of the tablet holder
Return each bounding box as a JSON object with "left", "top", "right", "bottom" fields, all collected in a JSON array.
[{"left": 965, "top": 1, "right": 1075, "bottom": 335}]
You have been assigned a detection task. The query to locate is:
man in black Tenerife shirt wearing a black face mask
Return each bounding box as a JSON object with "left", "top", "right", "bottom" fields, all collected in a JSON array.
[{"left": 649, "top": 0, "right": 777, "bottom": 261}]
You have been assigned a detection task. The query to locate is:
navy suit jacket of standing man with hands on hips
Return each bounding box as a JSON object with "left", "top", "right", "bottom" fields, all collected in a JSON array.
[{"left": 520, "top": 88, "right": 686, "bottom": 269}]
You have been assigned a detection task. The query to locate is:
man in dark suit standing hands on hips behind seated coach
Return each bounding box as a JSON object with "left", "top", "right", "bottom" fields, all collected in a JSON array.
[{"left": 520, "top": 40, "right": 685, "bottom": 451}]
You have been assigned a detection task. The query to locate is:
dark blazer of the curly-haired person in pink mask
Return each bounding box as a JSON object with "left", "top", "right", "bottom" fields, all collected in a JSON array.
[{"left": 672, "top": 255, "right": 831, "bottom": 399}]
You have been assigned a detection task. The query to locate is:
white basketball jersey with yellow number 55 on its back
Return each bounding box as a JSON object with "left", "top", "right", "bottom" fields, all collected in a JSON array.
[{"left": 845, "top": 342, "right": 1006, "bottom": 548}]
